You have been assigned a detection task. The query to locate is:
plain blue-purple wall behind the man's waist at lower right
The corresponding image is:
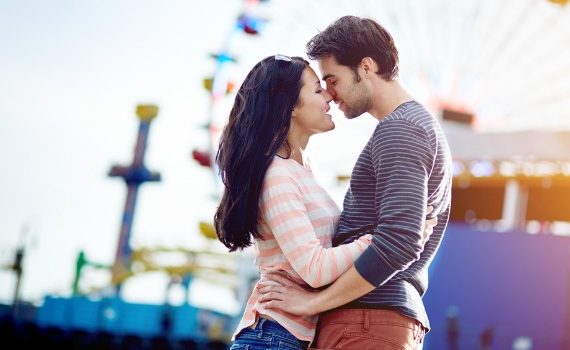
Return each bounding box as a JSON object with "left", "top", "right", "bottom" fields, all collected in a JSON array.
[{"left": 424, "top": 223, "right": 570, "bottom": 350}]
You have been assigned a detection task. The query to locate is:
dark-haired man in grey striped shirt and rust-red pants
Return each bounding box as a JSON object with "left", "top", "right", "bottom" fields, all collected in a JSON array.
[{"left": 261, "top": 16, "right": 452, "bottom": 350}]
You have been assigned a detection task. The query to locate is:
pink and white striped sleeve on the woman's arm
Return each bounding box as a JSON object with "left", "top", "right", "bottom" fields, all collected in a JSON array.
[{"left": 260, "top": 167, "right": 371, "bottom": 288}]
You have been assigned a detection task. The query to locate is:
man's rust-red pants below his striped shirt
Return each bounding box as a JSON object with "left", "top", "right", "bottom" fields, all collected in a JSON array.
[{"left": 309, "top": 309, "right": 425, "bottom": 350}]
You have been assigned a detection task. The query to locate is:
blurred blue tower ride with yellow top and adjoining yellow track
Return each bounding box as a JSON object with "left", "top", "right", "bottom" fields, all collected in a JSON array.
[{"left": 73, "top": 105, "right": 246, "bottom": 295}]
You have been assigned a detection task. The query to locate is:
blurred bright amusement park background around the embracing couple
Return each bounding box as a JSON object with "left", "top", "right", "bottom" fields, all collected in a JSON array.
[{"left": 0, "top": 0, "right": 570, "bottom": 350}]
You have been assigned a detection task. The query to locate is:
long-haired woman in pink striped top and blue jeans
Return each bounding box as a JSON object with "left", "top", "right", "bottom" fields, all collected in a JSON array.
[{"left": 214, "top": 55, "right": 430, "bottom": 350}]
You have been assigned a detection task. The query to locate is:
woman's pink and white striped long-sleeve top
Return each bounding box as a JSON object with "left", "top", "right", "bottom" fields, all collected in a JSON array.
[{"left": 234, "top": 157, "right": 371, "bottom": 341}]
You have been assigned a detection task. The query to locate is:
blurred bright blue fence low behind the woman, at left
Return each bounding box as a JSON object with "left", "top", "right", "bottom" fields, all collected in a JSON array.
[{"left": 37, "top": 297, "right": 235, "bottom": 341}]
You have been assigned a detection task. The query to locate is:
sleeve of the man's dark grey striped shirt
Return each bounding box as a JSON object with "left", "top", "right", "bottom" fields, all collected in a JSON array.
[{"left": 354, "top": 120, "right": 435, "bottom": 286}]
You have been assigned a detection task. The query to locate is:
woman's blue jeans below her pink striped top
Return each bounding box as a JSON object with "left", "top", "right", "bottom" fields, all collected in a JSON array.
[{"left": 230, "top": 317, "right": 309, "bottom": 350}]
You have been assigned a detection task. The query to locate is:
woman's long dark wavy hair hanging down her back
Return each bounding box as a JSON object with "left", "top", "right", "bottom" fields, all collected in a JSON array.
[{"left": 214, "top": 55, "right": 308, "bottom": 251}]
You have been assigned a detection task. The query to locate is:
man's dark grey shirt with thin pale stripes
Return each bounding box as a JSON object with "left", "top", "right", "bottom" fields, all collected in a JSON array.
[{"left": 333, "top": 101, "right": 452, "bottom": 329}]
